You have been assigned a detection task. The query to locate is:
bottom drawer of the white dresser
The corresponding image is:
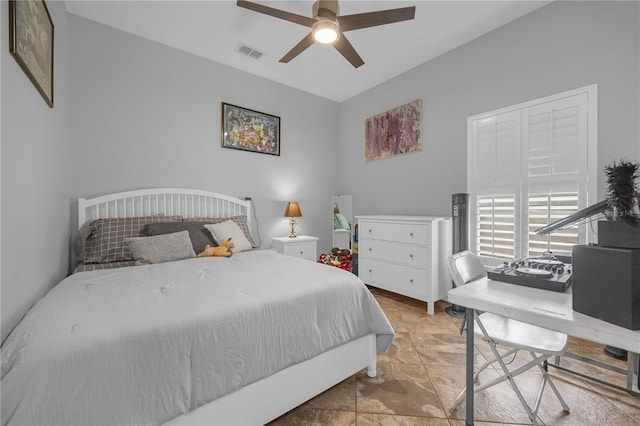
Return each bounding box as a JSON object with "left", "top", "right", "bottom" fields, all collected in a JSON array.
[{"left": 358, "top": 258, "right": 429, "bottom": 300}]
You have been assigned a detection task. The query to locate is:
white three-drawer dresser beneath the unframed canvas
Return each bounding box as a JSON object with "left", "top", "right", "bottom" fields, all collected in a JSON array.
[{"left": 356, "top": 216, "right": 452, "bottom": 314}]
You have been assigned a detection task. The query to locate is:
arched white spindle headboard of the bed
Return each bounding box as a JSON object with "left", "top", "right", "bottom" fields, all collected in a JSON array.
[{"left": 78, "top": 188, "right": 252, "bottom": 229}]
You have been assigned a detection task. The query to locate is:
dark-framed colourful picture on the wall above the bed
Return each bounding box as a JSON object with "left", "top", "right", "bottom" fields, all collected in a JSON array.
[{"left": 222, "top": 102, "right": 280, "bottom": 155}]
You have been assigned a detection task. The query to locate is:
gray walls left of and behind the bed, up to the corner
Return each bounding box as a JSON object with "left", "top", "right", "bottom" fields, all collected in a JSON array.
[{"left": 0, "top": 8, "right": 338, "bottom": 340}]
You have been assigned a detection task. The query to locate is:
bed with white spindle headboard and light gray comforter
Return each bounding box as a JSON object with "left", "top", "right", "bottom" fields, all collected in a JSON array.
[{"left": 1, "top": 189, "right": 394, "bottom": 425}]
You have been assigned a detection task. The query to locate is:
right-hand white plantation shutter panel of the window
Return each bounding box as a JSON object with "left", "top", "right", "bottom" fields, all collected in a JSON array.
[{"left": 520, "top": 93, "right": 588, "bottom": 256}]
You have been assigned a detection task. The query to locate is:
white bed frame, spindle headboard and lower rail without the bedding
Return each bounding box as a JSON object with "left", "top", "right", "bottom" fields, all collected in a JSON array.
[{"left": 78, "top": 188, "right": 377, "bottom": 425}]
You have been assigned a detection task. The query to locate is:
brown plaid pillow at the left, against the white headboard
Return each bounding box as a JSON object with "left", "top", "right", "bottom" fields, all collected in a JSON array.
[{"left": 84, "top": 216, "right": 182, "bottom": 263}]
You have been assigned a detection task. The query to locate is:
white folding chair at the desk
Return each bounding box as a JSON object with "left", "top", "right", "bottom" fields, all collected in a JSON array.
[{"left": 447, "top": 251, "right": 569, "bottom": 425}]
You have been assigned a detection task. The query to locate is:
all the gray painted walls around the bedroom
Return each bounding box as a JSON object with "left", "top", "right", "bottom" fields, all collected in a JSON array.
[{"left": 0, "top": 1, "right": 640, "bottom": 339}]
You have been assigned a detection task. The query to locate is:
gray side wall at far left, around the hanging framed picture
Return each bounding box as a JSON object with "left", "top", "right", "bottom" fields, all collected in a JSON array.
[{"left": 0, "top": 1, "right": 71, "bottom": 340}]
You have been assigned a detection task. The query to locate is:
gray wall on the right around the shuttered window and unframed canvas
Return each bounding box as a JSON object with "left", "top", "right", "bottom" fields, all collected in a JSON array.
[{"left": 339, "top": 2, "right": 640, "bottom": 215}]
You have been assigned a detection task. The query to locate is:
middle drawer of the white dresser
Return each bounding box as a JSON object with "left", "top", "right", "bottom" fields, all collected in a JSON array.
[{"left": 358, "top": 238, "right": 431, "bottom": 268}]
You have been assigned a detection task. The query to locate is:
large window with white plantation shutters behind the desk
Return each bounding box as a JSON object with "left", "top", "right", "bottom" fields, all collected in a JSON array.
[{"left": 467, "top": 85, "right": 597, "bottom": 260}]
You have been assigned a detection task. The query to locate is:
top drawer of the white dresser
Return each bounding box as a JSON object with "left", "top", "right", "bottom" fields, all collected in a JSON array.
[{"left": 358, "top": 220, "right": 431, "bottom": 245}]
